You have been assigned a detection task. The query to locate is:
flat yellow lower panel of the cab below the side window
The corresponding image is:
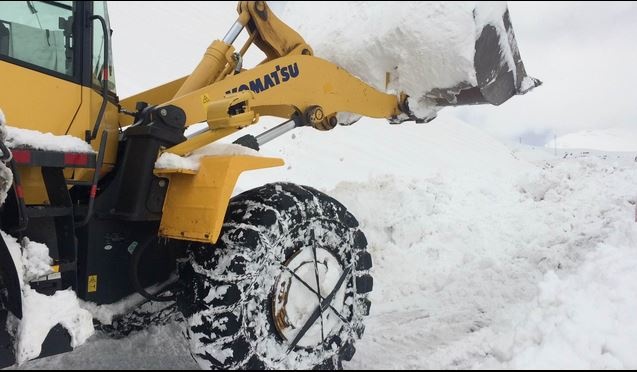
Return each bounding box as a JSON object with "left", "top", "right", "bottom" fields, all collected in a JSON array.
[{"left": 0, "top": 61, "right": 82, "bottom": 135}]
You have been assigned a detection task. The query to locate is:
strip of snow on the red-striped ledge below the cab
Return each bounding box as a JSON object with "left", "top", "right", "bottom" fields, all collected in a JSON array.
[{"left": 6, "top": 126, "right": 94, "bottom": 153}]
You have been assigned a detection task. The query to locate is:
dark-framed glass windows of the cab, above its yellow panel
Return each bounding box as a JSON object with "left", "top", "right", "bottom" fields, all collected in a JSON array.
[{"left": 0, "top": 1, "right": 115, "bottom": 93}]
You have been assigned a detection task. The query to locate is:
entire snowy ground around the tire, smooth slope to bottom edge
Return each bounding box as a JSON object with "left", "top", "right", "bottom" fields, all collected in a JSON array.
[{"left": 12, "top": 118, "right": 637, "bottom": 369}]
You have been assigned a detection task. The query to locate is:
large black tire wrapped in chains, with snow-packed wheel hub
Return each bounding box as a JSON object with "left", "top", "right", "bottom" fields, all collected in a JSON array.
[{"left": 177, "top": 183, "right": 373, "bottom": 369}]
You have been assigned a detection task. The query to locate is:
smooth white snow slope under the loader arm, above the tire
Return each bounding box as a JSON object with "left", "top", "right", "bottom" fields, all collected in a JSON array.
[{"left": 231, "top": 113, "right": 528, "bottom": 190}]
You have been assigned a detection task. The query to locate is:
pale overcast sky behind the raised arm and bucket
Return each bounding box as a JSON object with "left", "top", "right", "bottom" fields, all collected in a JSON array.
[{"left": 110, "top": 1, "right": 637, "bottom": 144}]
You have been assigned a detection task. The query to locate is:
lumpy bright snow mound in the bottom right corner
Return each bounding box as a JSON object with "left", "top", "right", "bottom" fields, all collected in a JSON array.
[{"left": 481, "top": 238, "right": 637, "bottom": 369}]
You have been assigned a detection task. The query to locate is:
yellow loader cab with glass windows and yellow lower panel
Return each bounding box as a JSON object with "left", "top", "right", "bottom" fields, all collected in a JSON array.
[{"left": 0, "top": 1, "right": 118, "bottom": 154}]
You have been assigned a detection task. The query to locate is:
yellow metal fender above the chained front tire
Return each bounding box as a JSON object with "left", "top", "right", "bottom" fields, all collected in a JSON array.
[{"left": 155, "top": 156, "right": 283, "bottom": 244}]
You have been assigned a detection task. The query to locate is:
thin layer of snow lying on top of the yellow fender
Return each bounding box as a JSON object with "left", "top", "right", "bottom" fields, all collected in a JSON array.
[{"left": 155, "top": 143, "right": 261, "bottom": 171}]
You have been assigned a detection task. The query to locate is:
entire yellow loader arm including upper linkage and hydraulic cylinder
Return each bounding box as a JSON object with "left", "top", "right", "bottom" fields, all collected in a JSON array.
[{"left": 121, "top": 1, "right": 406, "bottom": 155}]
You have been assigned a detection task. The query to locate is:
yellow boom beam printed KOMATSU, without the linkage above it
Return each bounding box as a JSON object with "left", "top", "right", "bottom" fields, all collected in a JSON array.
[{"left": 161, "top": 55, "right": 401, "bottom": 155}]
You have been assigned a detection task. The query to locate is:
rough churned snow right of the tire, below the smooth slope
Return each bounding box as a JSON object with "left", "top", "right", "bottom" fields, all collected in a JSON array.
[{"left": 338, "top": 151, "right": 637, "bottom": 369}]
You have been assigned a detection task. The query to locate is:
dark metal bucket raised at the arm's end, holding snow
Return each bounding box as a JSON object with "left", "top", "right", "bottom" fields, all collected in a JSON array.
[{"left": 425, "top": 9, "right": 542, "bottom": 106}]
